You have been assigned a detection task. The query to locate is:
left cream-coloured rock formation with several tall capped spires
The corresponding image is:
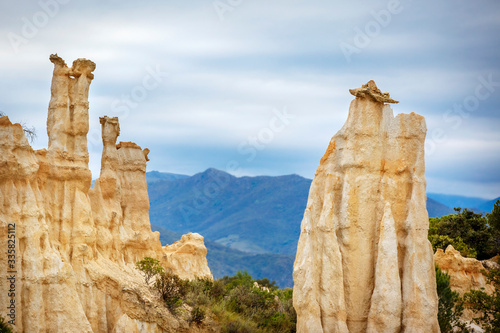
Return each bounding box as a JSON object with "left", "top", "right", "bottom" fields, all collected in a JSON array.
[{"left": 0, "top": 55, "right": 211, "bottom": 333}]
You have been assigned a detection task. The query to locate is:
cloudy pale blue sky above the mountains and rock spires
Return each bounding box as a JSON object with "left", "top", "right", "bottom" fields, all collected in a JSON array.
[{"left": 0, "top": 0, "right": 500, "bottom": 199}]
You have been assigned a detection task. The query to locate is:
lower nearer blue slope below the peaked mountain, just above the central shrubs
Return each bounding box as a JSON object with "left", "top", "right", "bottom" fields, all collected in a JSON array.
[{"left": 151, "top": 224, "right": 295, "bottom": 288}]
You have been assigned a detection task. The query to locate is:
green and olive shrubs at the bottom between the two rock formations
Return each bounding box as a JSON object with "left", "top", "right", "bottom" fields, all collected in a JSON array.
[{"left": 137, "top": 258, "right": 297, "bottom": 333}]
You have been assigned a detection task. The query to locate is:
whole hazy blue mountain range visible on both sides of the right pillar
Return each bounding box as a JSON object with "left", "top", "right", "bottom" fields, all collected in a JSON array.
[{"left": 146, "top": 168, "right": 496, "bottom": 287}]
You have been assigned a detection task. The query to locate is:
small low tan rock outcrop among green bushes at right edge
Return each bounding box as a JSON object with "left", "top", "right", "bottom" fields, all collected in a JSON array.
[{"left": 434, "top": 245, "right": 495, "bottom": 296}]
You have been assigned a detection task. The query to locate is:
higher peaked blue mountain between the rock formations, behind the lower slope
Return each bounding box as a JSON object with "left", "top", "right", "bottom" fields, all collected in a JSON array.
[{"left": 148, "top": 169, "right": 311, "bottom": 255}]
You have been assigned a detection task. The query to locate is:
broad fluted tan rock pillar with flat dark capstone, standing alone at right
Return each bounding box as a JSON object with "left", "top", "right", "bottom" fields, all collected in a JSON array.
[{"left": 293, "top": 81, "right": 439, "bottom": 333}]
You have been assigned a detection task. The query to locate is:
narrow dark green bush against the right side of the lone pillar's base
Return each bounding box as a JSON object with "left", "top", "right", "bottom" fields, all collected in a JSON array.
[{"left": 436, "top": 266, "right": 467, "bottom": 333}]
